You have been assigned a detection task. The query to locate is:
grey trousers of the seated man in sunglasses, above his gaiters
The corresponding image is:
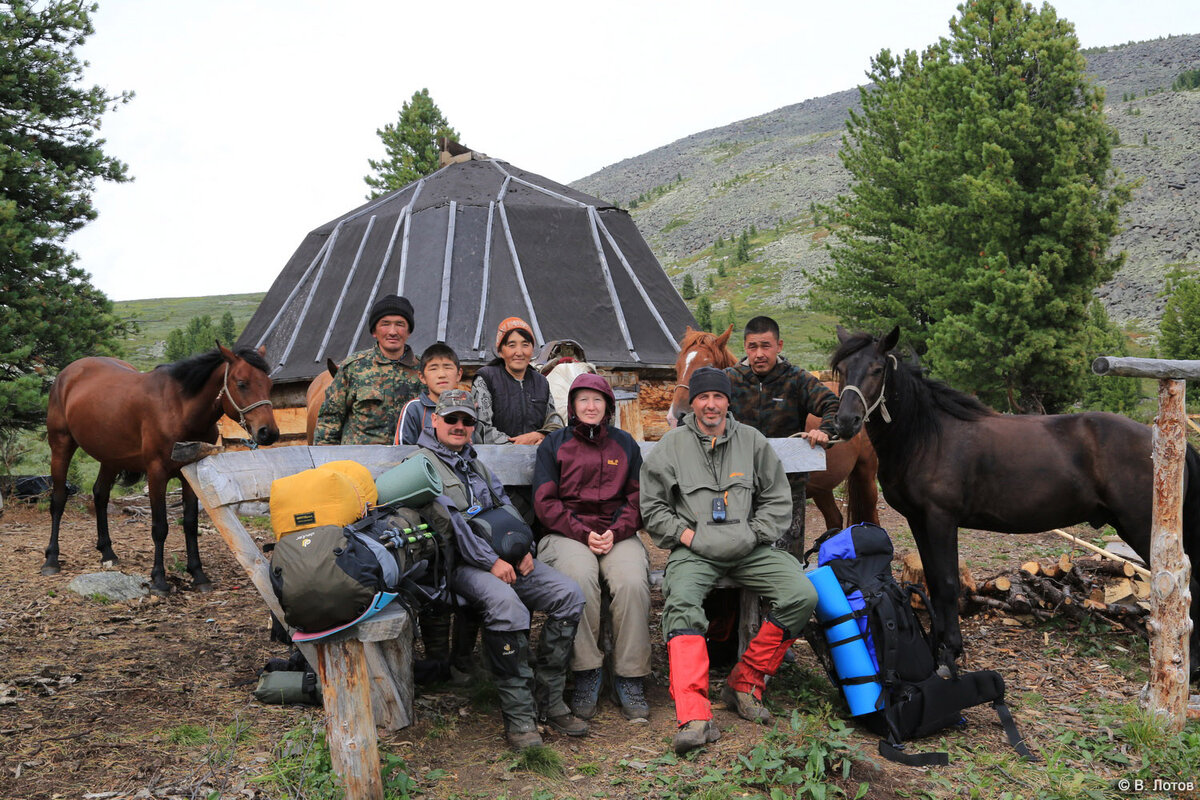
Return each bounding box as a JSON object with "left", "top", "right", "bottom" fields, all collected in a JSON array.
[{"left": 451, "top": 559, "right": 583, "bottom": 631}]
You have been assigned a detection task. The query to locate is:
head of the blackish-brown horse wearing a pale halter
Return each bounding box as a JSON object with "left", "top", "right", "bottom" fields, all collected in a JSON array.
[{"left": 829, "top": 325, "right": 900, "bottom": 439}]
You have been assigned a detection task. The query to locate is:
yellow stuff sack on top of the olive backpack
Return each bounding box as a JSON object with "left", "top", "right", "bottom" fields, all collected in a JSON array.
[{"left": 270, "top": 462, "right": 379, "bottom": 540}]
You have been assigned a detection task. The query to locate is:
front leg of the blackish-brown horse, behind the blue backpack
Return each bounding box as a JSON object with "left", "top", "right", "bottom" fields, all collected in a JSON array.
[{"left": 912, "top": 517, "right": 962, "bottom": 678}]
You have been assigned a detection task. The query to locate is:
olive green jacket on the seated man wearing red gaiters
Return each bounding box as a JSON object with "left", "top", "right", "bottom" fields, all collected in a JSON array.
[{"left": 641, "top": 414, "right": 792, "bottom": 561}]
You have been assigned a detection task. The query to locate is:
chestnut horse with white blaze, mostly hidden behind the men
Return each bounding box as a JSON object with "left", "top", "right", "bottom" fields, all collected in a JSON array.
[{"left": 667, "top": 325, "right": 880, "bottom": 530}]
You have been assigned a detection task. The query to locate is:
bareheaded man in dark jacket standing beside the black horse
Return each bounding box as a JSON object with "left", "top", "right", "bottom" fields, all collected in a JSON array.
[{"left": 726, "top": 317, "right": 839, "bottom": 558}]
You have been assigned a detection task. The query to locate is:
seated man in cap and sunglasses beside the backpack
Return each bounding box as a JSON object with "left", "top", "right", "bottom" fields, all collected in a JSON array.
[{"left": 403, "top": 389, "right": 588, "bottom": 750}]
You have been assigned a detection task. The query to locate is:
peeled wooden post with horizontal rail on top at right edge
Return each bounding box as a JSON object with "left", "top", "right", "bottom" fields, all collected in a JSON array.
[{"left": 1092, "top": 356, "right": 1200, "bottom": 733}]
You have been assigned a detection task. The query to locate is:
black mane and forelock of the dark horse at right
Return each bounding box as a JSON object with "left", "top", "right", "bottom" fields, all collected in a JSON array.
[{"left": 829, "top": 333, "right": 997, "bottom": 450}]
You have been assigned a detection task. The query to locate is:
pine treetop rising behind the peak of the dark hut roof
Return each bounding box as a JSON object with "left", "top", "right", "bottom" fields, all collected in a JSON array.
[{"left": 362, "top": 89, "right": 458, "bottom": 199}]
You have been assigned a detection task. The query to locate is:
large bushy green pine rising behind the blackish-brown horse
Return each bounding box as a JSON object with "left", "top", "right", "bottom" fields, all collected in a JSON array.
[{"left": 812, "top": 0, "right": 1129, "bottom": 411}]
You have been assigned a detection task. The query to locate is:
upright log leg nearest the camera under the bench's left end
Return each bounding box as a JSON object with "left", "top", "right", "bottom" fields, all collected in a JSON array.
[{"left": 317, "top": 639, "right": 383, "bottom": 800}]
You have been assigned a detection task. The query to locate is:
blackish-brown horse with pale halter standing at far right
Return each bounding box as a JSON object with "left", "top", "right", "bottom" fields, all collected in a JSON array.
[{"left": 830, "top": 326, "right": 1200, "bottom": 680}]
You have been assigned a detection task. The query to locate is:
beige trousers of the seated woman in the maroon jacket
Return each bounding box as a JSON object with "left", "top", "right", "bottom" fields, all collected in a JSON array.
[{"left": 539, "top": 534, "right": 650, "bottom": 678}]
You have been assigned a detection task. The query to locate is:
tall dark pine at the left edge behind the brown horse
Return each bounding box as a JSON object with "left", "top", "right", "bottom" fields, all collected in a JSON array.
[{"left": 0, "top": 0, "right": 133, "bottom": 439}]
